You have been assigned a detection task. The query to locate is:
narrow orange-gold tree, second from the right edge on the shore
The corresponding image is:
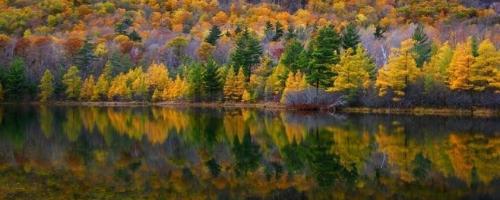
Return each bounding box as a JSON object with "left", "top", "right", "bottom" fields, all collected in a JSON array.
[{"left": 448, "top": 38, "right": 474, "bottom": 90}]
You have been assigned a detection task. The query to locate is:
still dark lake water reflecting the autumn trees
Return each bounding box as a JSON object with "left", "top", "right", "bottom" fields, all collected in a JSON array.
[{"left": 0, "top": 106, "right": 500, "bottom": 199}]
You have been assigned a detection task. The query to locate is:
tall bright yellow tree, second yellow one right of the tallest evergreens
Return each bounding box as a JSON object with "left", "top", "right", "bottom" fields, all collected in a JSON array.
[{"left": 375, "top": 39, "right": 419, "bottom": 101}]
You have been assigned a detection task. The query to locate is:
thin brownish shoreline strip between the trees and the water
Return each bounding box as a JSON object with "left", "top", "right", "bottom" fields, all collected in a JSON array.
[{"left": 0, "top": 101, "right": 500, "bottom": 118}]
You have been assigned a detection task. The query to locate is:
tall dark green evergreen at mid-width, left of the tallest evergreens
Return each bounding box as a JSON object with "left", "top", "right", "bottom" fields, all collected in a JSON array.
[{"left": 231, "top": 29, "right": 262, "bottom": 77}]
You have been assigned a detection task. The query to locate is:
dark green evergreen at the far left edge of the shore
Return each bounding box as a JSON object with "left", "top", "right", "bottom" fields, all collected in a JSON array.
[{"left": 5, "top": 58, "right": 28, "bottom": 99}]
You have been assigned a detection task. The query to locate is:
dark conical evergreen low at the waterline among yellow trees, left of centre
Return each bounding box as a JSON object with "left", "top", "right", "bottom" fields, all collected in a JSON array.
[{"left": 202, "top": 60, "right": 221, "bottom": 100}]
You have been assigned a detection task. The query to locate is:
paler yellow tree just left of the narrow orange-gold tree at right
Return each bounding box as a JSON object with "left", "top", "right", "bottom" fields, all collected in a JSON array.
[{"left": 422, "top": 42, "right": 453, "bottom": 90}]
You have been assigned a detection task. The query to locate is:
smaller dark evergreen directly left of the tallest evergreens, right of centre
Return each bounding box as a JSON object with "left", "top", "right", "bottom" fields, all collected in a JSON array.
[{"left": 280, "top": 40, "right": 305, "bottom": 72}]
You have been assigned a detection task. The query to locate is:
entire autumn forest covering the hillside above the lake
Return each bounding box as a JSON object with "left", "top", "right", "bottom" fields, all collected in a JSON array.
[{"left": 0, "top": 0, "right": 500, "bottom": 107}]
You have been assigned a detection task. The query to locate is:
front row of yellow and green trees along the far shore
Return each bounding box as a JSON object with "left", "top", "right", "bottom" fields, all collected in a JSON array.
[{"left": 0, "top": 24, "right": 500, "bottom": 107}]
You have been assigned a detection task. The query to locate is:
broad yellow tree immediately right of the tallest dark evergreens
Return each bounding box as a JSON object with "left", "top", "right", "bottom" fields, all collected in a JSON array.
[{"left": 330, "top": 48, "right": 373, "bottom": 95}]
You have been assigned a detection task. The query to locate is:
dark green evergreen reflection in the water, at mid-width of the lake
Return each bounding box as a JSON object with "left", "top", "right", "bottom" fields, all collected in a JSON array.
[{"left": 233, "top": 130, "right": 262, "bottom": 175}]
